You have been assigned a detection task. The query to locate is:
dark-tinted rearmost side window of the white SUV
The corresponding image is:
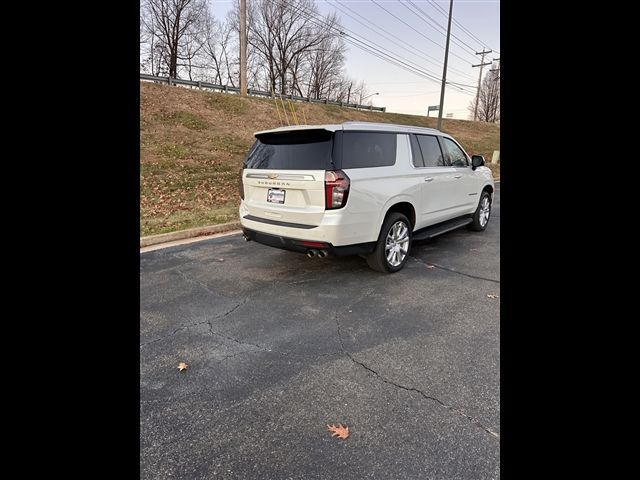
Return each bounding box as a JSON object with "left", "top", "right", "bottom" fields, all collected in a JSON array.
[{"left": 342, "top": 132, "right": 398, "bottom": 168}]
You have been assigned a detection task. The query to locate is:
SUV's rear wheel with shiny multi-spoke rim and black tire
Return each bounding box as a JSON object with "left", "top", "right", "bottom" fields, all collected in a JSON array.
[{"left": 367, "top": 212, "right": 411, "bottom": 273}]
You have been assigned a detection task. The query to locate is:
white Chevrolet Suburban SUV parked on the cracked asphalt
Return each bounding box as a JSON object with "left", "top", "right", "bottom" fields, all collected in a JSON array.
[{"left": 240, "top": 122, "right": 494, "bottom": 272}]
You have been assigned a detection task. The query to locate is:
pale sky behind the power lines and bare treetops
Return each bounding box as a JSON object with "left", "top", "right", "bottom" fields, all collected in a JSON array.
[{"left": 210, "top": 0, "right": 500, "bottom": 119}]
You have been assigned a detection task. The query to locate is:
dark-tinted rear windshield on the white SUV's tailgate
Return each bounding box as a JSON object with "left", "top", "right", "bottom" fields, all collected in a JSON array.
[{"left": 244, "top": 130, "right": 333, "bottom": 170}]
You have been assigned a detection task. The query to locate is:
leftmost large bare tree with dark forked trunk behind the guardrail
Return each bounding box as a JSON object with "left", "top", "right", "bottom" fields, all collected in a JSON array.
[{"left": 145, "top": 0, "right": 207, "bottom": 78}]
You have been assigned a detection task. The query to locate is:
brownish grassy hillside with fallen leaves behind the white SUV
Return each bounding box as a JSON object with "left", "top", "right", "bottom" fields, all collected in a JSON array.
[{"left": 140, "top": 82, "right": 500, "bottom": 235}]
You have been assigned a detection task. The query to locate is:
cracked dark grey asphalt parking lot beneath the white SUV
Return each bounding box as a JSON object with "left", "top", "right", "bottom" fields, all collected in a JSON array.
[{"left": 140, "top": 187, "right": 500, "bottom": 480}]
